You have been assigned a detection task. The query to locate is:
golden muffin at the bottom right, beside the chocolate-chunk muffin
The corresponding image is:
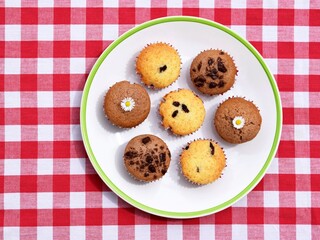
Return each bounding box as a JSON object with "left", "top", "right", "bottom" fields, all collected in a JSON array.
[{"left": 180, "top": 139, "right": 226, "bottom": 185}]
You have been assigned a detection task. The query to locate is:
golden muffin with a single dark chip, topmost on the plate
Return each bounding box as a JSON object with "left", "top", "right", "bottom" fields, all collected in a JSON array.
[{"left": 136, "top": 43, "right": 181, "bottom": 88}]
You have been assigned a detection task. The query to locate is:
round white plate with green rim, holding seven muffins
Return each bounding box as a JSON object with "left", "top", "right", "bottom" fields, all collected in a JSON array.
[{"left": 81, "top": 17, "right": 282, "bottom": 218}]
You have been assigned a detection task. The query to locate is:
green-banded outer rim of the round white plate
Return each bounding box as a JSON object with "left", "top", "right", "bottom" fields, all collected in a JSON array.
[{"left": 80, "top": 16, "right": 282, "bottom": 218}]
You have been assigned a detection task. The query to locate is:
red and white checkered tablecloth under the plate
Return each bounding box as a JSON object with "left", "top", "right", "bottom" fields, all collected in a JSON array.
[{"left": 0, "top": 0, "right": 320, "bottom": 240}]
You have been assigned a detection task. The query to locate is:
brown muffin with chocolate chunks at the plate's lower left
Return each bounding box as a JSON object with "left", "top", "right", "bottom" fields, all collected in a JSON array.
[{"left": 123, "top": 134, "right": 171, "bottom": 182}]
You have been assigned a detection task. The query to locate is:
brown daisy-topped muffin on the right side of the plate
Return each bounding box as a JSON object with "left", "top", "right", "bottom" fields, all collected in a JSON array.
[{"left": 214, "top": 97, "right": 262, "bottom": 143}]
